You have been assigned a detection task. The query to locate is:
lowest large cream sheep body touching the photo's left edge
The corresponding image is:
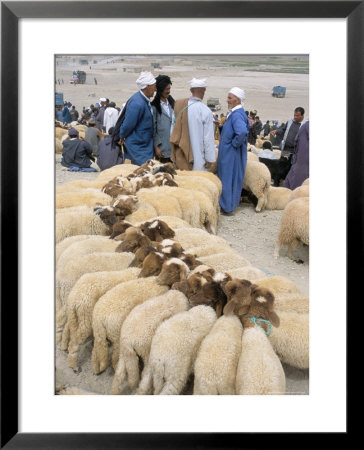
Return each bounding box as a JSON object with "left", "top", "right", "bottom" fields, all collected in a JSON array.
[{"left": 56, "top": 252, "right": 134, "bottom": 343}]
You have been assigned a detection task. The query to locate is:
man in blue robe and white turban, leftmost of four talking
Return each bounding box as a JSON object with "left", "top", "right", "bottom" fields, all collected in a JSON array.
[{"left": 119, "top": 72, "right": 156, "bottom": 166}]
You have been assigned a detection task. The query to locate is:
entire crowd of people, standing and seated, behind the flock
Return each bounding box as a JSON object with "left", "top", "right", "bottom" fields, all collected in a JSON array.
[{"left": 57, "top": 72, "right": 309, "bottom": 215}]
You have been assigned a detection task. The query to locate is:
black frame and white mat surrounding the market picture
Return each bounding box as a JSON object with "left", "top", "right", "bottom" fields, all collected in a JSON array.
[{"left": 1, "top": 1, "right": 358, "bottom": 449}]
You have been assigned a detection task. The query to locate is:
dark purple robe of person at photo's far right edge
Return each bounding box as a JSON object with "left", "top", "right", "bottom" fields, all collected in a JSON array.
[{"left": 283, "top": 121, "right": 310, "bottom": 190}]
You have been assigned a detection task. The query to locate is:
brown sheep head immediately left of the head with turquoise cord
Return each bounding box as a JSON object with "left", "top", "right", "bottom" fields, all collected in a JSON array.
[{"left": 223, "top": 278, "right": 255, "bottom": 317}]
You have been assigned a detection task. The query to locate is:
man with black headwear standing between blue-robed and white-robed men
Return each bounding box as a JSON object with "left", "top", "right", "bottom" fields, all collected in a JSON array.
[{"left": 151, "top": 75, "right": 174, "bottom": 163}]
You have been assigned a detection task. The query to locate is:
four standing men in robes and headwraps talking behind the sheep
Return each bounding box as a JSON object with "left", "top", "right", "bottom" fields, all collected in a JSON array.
[{"left": 61, "top": 72, "right": 308, "bottom": 215}]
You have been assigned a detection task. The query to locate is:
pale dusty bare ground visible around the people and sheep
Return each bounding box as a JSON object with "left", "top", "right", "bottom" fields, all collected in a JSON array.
[{"left": 55, "top": 57, "right": 309, "bottom": 395}]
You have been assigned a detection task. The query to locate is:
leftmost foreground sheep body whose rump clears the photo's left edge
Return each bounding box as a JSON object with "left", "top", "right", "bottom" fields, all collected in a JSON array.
[{"left": 61, "top": 267, "right": 140, "bottom": 371}]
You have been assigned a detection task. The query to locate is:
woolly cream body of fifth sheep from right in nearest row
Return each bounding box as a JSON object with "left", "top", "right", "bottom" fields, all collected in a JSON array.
[{"left": 91, "top": 277, "right": 169, "bottom": 374}]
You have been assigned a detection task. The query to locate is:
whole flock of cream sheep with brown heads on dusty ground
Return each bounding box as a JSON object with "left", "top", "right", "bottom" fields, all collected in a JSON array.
[{"left": 56, "top": 137, "right": 309, "bottom": 395}]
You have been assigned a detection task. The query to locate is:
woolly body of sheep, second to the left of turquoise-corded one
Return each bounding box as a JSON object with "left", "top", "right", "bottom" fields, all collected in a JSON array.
[{"left": 136, "top": 305, "right": 216, "bottom": 395}]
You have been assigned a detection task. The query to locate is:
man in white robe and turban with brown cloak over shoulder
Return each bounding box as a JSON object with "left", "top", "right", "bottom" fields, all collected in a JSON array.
[{"left": 171, "top": 78, "right": 216, "bottom": 170}]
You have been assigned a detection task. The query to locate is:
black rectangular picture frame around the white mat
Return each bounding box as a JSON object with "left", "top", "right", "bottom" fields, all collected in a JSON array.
[{"left": 0, "top": 0, "right": 358, "bottom": 449}]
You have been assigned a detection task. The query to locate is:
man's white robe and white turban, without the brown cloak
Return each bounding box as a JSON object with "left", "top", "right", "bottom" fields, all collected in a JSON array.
[{"left": 187, "top": 78, "right": 216, "bottom": 170}]
